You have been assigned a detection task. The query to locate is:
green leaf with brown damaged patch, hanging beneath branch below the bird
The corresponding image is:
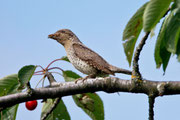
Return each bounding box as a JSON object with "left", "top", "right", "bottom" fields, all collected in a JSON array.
[{"left": 73, "top": 93, "right": 104, "bottom": 120}]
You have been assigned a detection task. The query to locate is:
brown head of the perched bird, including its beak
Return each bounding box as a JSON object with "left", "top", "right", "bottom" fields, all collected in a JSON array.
[{"left": 48, "top": 29, "right": 76, "bottom": 46}]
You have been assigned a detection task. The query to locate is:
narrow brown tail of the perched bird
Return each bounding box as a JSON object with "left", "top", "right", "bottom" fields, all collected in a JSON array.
[{"left": 110, "top": 65, "right": 132, "bottom": 75}]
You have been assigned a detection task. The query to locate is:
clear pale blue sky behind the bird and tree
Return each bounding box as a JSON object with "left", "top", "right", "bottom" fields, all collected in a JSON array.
[{"left": 0, "top": 0, "right": 180, "bottom": 120}]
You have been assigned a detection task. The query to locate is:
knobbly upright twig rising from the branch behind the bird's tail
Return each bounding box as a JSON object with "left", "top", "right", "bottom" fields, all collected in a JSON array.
[{"left": 132, "top": 32, "right": 150, "bottom": 79}]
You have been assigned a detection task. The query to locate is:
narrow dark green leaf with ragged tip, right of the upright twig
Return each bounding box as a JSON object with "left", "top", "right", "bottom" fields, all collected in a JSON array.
[{"left": 154, "top": 10, "right": 173, "bottom": 71}]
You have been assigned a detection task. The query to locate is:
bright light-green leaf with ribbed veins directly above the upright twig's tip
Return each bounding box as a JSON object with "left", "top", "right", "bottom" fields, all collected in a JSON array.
[{"left": 143, "top": 0, "right": 172, "bottom": 32}]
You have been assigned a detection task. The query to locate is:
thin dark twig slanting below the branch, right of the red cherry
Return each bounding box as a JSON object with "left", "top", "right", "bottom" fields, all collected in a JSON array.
[{"left": 41, "top": 97, "right": 61, "bottom": 120}]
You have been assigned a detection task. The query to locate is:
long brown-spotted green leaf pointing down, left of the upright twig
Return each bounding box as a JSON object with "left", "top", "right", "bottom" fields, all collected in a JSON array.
[{"left": 123, "top": 2, "right": 148, "bottom": 66}]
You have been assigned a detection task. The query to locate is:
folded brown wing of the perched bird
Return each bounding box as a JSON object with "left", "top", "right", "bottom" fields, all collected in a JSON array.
[{"left": 73, "top": 43, "right": 114, "bottom": 75}]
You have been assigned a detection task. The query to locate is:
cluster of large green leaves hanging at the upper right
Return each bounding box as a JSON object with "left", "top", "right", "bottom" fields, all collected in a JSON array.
[{"left": 123, "top": 0, "right": 180, "bottom": 71}]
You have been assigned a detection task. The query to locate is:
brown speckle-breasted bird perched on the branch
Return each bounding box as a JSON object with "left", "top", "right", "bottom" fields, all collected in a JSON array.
[{"left": 48, "top": 29, "right": 132, "bottom": 78}]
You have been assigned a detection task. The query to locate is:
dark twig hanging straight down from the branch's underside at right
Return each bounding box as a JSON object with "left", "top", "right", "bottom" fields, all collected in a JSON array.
[{"left": 149, "top": 96, "right": 155, "bottom": 120}]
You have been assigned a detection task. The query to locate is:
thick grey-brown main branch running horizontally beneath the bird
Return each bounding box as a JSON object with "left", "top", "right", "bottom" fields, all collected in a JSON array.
[{"left": 0, "top": 77, "right": 180, "bottom": 109}]
